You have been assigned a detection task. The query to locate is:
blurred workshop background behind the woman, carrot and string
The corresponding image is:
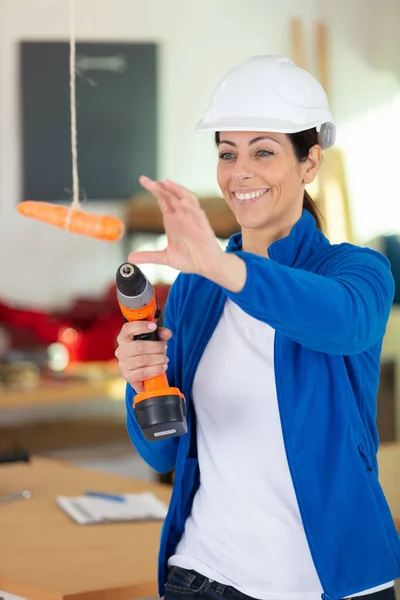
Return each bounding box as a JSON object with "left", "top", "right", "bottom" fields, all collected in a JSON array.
[{"left": 0, "top": 0, "right": 400, "bottom": 480}]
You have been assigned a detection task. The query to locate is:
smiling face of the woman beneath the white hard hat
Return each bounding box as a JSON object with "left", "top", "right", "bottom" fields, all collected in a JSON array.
[{"left": 217, "top": 131, "right": 321, "bottom": 239}]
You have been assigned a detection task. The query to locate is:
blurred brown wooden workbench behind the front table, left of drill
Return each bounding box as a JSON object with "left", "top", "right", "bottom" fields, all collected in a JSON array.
[{"left": 0, "top": 375, "right": 126, "bottom": 453}]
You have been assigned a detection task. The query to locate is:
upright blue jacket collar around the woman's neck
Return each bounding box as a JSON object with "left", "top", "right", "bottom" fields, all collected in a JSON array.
[{"left": 227, "top": 209, "right": 329, "bottom": 268}]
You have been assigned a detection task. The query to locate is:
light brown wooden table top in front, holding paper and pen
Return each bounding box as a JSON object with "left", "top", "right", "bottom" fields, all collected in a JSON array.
[{"left": 0, "top": 458, "right": 171, "bottom": 600}]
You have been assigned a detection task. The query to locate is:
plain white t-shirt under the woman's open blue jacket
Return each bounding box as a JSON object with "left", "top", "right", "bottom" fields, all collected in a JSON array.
[{"left": 169, "top": 300, "right": 393, "bottom": 600}]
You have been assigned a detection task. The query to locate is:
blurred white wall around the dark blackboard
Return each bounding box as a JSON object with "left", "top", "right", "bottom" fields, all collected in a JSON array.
[{"left": 0, "top": 0, "right": 399, "bottom": 306}]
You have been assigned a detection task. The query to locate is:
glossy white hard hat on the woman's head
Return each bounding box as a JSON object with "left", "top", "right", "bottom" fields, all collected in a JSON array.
[{"left": 196, "top": 56, "right": 336, "bottom": 148}]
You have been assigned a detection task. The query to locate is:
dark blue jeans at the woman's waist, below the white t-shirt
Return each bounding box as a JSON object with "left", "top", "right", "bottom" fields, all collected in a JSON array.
[{"left": 164, "top": 567, "right": 396, "bottom": 600}]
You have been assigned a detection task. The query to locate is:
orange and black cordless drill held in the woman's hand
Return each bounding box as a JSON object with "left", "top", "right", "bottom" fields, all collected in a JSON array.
[{"left": 116, "top": 263, "right": 187, "bottom": 442}]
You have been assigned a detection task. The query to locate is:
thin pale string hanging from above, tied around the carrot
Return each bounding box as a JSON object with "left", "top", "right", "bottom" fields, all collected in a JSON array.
[{"left": 66, "top": 0, "right": 81, "bottom": 229}]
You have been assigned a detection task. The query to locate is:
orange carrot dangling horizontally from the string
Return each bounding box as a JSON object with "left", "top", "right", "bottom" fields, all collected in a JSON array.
[{"left": 18, "top": 200, "right": 125, "bottom": 242}]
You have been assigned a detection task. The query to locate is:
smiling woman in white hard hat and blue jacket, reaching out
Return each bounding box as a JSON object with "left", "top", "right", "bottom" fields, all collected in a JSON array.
[{"left": 117, "top": 57, "right": 400, "bottom": 600}]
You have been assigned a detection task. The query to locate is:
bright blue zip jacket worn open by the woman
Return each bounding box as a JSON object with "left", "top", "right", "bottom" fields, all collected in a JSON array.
[{"left": 126, "top": 211, "right": 400, "bottom": 600}]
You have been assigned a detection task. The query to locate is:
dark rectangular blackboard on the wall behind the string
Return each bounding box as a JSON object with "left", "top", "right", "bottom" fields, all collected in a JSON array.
[{"left": 20, "top": 42, "right": 157, "bottom": 202}]
